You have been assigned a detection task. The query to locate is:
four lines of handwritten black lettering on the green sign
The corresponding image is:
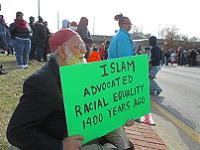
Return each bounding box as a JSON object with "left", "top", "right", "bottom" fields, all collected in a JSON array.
[{"left": 74, "top": 60, "right": 145, "bottom": 129}]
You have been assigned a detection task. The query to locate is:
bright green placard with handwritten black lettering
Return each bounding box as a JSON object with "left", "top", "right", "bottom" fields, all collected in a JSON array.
[{"left": 60, "top": 55, "right": 150, "bottom": 143}]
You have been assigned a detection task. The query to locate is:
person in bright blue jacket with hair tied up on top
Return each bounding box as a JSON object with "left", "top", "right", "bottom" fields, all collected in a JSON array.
[{"left": 108, "top": 14, "right": 135, "bottom": 59}]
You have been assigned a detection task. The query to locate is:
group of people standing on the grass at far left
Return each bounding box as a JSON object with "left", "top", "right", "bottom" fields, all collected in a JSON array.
[{"left": 0, "top": 12, "right": 51, "bottom": 69}]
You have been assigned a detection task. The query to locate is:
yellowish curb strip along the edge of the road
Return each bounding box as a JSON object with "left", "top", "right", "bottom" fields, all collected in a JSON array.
[{"left": 151, "top": 100, "right": 200, "bottom": 145}]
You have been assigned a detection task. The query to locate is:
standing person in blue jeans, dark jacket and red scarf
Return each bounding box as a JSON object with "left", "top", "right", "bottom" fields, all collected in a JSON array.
[{"left": 9, "top": 12, "right": 32, "bottom": 69}]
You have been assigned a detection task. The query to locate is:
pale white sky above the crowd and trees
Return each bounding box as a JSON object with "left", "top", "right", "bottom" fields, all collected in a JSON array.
[{"left": 0, "top": 0, "right": 200, "bottom": 37}]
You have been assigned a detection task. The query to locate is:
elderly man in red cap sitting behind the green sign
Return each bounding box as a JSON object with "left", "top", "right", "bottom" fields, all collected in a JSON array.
[{"left": 7, "top": 29, "right": 133, "bottom": 150}]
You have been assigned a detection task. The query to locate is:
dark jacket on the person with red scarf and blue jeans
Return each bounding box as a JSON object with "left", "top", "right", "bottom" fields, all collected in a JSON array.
[{"left": 9, "top": 22, "right": 32, "bottom": 39}]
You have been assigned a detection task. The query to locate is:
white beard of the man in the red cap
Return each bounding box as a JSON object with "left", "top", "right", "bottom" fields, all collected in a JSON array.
[{"left": 65, "top": 47, "right": 86, "bottom": 65}]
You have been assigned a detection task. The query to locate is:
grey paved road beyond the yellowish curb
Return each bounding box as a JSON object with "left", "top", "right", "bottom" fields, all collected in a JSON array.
[{"left": 152, "top": 66, "right": 200, "bottom": 133}]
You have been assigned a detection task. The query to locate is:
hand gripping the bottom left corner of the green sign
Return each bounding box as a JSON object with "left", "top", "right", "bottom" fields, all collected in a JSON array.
[{"left": 63, "top": 135, "right": 83, "bottom": 150}]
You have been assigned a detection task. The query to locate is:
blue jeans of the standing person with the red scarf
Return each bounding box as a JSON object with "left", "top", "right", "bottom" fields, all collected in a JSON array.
[{"left": 14, "top": 38, "right": 31, "bottom": 65}]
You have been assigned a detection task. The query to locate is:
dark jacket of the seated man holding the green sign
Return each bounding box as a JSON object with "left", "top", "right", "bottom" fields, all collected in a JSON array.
[{"left": 7, "top": 59, "right": 67, "bottom": 150}]
